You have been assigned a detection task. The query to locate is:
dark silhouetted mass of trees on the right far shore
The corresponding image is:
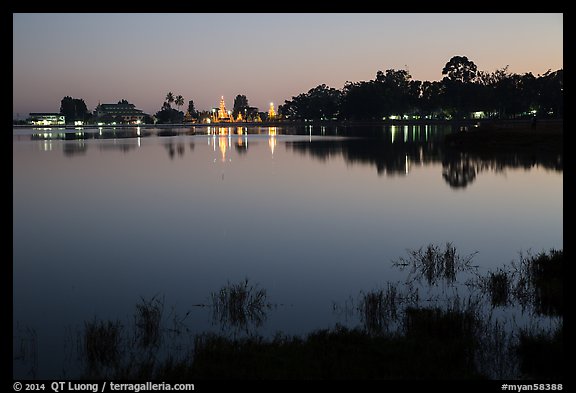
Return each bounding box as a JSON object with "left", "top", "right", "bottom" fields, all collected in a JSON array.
[{"left": 279, "top": 56, "right": 564, "bottom": 121}]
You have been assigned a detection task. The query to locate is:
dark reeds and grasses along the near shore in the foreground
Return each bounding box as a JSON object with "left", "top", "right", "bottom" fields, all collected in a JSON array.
[{"left": 15, "top": 243, "right": 566, "bottom": 383}]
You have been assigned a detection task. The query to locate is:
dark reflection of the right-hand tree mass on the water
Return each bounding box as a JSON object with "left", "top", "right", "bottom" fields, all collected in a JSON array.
[{"left": 286, "top": 126, "right": 564, "bottom": 188}]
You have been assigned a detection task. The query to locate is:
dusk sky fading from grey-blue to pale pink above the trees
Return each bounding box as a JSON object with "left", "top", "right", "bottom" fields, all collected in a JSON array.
[{"left": 13, "top": 13, "right": 563, "bottom": 118}]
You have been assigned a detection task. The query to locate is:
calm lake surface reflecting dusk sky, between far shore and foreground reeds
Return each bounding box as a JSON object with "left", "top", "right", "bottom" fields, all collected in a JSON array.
[{"left": 13, "top": 125, "right": 563, "bottom": 379}]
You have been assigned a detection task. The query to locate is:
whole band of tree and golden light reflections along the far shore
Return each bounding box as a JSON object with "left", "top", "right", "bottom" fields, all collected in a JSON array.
[{"left": 19, "top": 125, "right": 563, "bottom": 188}]
